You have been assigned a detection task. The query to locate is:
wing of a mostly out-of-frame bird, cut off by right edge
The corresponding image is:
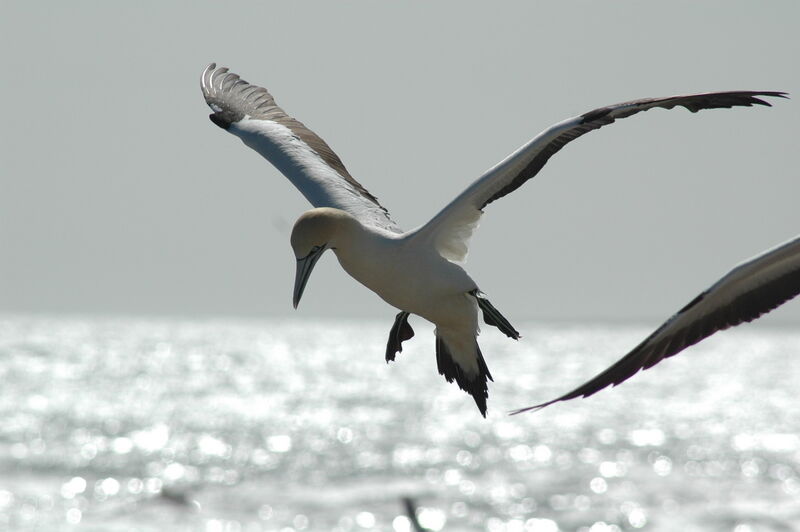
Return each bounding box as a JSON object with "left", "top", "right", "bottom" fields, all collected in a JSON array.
[{"left": 512, "top": 237, "right": 800, "bottom": 414}]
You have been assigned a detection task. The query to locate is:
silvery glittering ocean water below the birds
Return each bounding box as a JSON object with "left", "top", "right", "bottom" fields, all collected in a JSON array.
[{"left": 0, "top": 314, "right": 800, "bottom": 532}]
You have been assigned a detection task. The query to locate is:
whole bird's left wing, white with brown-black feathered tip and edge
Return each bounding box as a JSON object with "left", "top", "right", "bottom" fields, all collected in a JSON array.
[{"left": 200, "top": 63, "right": 400, "bottom": 233}]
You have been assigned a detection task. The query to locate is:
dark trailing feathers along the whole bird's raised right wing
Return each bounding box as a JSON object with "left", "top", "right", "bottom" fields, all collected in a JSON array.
[{"left": 479, "top": 91, "right": 788, "bottom": 210}]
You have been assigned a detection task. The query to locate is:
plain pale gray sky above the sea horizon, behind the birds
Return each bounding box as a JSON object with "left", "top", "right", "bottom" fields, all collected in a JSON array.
[{"left": 0, "top": 0, "right": 800, "bottom": 323}]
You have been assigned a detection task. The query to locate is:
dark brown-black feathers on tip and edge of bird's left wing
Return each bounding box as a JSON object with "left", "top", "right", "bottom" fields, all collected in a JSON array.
[{"left": 200, "top": 63, "right": 393, "bottom": 223}]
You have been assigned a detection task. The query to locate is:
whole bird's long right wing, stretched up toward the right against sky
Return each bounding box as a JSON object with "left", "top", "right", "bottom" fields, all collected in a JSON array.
[{"left": 417, "top": 91, "right": 786, "bottom": 262}]
